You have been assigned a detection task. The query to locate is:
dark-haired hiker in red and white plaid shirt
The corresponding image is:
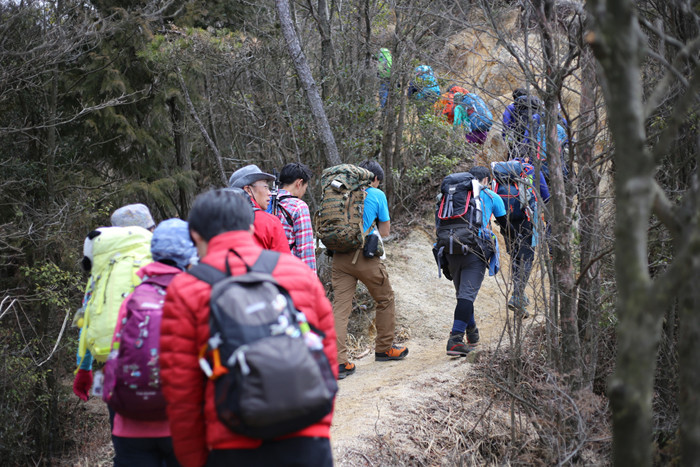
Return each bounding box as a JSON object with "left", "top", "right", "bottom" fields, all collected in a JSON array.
[{"left": 273, "top": 162, "right": 316, "bottom": 272}]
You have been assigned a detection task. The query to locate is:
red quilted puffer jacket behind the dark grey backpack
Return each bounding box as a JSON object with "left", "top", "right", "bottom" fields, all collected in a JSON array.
[{"left": 160, "top": 231, "right": 338, "bottom": 467}]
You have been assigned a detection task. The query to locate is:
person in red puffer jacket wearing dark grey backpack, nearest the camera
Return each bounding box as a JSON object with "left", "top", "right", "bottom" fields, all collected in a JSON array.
[{"left": 160, "top": 190, "right": 337, "bottom": 467}]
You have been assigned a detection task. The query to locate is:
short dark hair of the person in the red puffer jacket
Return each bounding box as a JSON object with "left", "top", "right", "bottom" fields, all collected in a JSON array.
[{"left": 187, "top": 189, "right": 255, "bottom": 241}]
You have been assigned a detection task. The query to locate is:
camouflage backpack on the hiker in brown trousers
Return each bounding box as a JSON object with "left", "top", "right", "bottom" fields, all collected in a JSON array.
[{"left": 315, "top": 164, "right": 374, "bottom": 253}]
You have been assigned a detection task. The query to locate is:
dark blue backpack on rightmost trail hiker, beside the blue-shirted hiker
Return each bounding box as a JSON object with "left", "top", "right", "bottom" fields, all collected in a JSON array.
[{"left": 491, "top": 160, "right": 536, "bottom": 221}]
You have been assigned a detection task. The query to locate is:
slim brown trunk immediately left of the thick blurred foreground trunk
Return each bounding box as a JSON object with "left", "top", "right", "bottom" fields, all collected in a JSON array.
[{"left": 572, "top": 41, "right": 600, "bottom": 389}]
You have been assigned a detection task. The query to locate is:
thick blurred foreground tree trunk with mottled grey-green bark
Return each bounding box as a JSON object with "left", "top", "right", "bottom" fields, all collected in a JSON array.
[{"left": 587, "top": 0, "right": 680, "bottom": 467}]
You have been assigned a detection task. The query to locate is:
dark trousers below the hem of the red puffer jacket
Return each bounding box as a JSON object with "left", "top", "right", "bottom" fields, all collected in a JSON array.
[{"left": 207, "top": 437, "right": 333, "bottom": 467}]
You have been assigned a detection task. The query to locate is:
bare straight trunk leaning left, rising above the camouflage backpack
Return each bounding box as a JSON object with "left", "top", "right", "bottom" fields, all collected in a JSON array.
[{"left": 276, "top": 0, "right": 342, "bottom": 165}]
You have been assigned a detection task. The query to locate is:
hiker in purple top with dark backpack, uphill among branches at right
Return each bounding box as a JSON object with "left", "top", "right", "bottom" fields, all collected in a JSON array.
[{"left": 502, "top": 88, "right": 542, "bottom": 159}]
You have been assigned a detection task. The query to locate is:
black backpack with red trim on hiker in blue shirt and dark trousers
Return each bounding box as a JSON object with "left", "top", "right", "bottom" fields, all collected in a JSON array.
[{"left": 435, "top": 172, "right": 482, "bottom": 255}]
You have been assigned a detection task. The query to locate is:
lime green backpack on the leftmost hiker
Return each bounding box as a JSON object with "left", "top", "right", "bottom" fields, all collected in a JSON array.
[{"left": 78, "top": 227, "right": 153, "bottom": 362}]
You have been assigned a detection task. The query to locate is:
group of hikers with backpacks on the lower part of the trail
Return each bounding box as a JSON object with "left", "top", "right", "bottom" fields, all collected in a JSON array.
[{"left": 73, "top": 53, "right": 564, "bottom": 467}]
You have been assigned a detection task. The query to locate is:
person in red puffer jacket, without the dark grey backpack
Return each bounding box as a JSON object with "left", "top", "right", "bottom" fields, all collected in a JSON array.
[{"left": 160, "top": 190, "right": 338, "bottom": 467}]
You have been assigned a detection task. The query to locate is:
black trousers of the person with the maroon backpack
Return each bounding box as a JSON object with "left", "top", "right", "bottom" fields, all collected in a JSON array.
[{"left": 112, "top": 435, "right": 180, "bottom": 467}]
